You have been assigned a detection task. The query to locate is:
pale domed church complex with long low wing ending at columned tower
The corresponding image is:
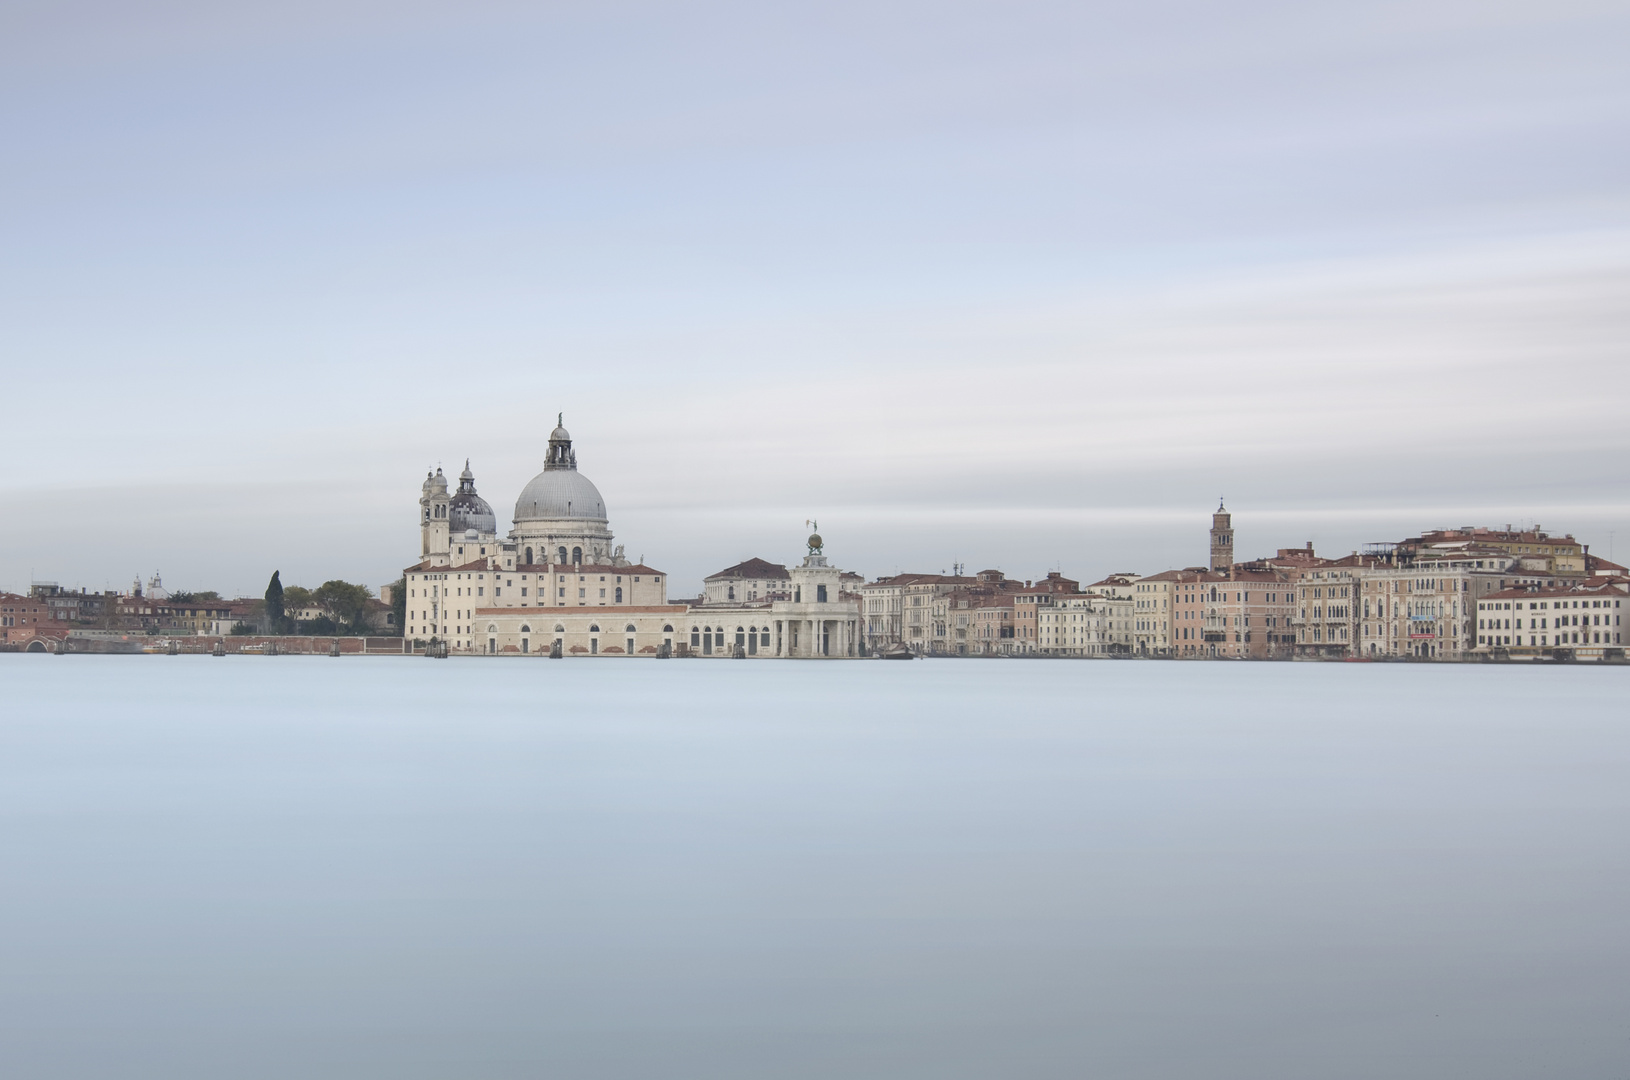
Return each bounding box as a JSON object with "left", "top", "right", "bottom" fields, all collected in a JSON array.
[{"left": 403, "top": 424, "right": 861, "bottom": 658}]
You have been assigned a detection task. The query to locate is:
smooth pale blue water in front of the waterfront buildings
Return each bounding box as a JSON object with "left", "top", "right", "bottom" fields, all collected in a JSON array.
[{"left": 0, "top": 655, "right": 1630, "bottom": 1080}]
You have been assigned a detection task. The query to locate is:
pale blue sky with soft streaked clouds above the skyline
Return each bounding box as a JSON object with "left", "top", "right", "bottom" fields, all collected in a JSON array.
[{"left": 0, "top": 0, "right": 1630, "bottom": 595}]
